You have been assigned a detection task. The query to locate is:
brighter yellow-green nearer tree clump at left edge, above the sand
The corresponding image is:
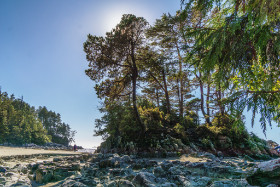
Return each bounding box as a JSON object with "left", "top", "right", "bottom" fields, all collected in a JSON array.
[{"left": 0, "top": 90, "right": 50, "bottom": 145}]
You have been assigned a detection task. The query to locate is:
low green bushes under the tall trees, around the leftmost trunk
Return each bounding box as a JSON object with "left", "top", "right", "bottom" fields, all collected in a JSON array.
[{"left": 95, "top": 99, "right": 197, "bottom": 147}]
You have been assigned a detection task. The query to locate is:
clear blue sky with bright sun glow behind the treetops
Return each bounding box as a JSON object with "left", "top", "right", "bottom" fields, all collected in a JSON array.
[{"left": 0, "top": 0, "right": 280, "bottom": 147}]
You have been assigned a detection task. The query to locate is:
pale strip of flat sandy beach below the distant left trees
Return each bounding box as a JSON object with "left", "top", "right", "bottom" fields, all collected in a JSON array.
[{"left": 0, "top": 146, "right": 81, "bottom": 157}]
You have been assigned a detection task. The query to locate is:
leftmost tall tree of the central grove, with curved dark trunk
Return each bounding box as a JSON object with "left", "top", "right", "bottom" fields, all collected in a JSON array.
[{"left": 84, "top": 14, "right": 148, "bottom": 132}]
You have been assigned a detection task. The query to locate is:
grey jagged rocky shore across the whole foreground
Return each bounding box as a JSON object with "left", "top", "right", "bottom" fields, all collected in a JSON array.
[{"left": 0, "top": 152, "right": 280, "bottom": 187}]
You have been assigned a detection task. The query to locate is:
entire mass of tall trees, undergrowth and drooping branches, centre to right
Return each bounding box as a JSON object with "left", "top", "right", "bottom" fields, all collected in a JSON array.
[{"left": 84, "top": 0, "right": 280, "bottom": 150}]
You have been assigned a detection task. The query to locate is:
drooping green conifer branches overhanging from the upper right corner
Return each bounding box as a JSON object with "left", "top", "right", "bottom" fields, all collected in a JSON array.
[{"left": 182, "top": 0, "right": 280, "bottom": 132}]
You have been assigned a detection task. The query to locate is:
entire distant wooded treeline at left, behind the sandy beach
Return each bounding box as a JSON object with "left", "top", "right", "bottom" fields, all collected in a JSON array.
[{"left": 0, "top": 90, "right": 76, "bottom": 145}]
